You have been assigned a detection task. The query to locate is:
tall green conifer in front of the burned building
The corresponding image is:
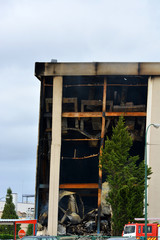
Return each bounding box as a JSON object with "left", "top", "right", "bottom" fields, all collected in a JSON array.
[{"left": 100, "top": 116, "right": 151, "bottom": 236}]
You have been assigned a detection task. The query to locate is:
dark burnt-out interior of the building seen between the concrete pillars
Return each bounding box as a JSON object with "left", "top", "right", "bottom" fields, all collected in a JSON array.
[{"left": 36, "top": 76, "right": 148, "bottom": 227}]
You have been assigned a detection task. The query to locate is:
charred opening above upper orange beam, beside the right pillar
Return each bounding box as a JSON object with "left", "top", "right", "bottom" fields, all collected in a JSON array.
[{"left": 107, "top": 76, "right": 148, "bottom": 112}]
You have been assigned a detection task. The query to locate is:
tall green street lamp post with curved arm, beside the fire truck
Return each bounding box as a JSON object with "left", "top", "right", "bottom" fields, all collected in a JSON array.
[{"left": 145, "top": 123, "right": 160, "bottom": 240}]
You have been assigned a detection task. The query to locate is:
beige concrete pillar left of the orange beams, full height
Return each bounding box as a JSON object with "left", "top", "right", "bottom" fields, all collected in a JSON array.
[{"left": 48, "top": 77, "right": 63, "bottom": 235}]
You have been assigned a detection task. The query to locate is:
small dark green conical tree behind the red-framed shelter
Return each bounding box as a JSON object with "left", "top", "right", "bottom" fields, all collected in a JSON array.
[{"left": 0, "top": 188, "right": 20, "bottom": 234}]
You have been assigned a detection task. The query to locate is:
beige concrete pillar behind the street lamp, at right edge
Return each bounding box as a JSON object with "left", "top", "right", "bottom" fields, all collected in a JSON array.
[{"left": 146, "top": 77, "right": 160, "bottom": 218}]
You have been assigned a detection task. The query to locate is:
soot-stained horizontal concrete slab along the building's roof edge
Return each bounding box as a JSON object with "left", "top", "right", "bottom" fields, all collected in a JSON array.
[{"left": 35, "top": 62, "right": 160, "bottom": 80}]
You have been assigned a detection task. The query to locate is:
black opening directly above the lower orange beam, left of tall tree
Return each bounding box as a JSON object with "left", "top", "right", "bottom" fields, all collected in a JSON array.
[{"left": 60, "top": 141, "right": 99, "bottom": 183}]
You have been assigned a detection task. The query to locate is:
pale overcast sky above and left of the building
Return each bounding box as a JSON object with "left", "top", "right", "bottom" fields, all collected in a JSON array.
[{"left": 0, "top": 0, "right": 160, "bottom": 201}]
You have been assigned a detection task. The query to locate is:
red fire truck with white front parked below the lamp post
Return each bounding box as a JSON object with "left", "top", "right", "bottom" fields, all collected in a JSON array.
[{"left": 122, "top": 223, "right": 160, "bottom": 240}]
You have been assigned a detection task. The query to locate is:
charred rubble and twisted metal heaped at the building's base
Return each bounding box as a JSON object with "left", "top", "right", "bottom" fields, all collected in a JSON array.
[{"left": 39, "top": 183, "right": 111, "bottom": 236}]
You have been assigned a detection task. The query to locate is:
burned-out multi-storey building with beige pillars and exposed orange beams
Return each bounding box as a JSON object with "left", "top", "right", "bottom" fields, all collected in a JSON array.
[{"left": 35, "top": 62, "right": 160, "bottom": 235}]
